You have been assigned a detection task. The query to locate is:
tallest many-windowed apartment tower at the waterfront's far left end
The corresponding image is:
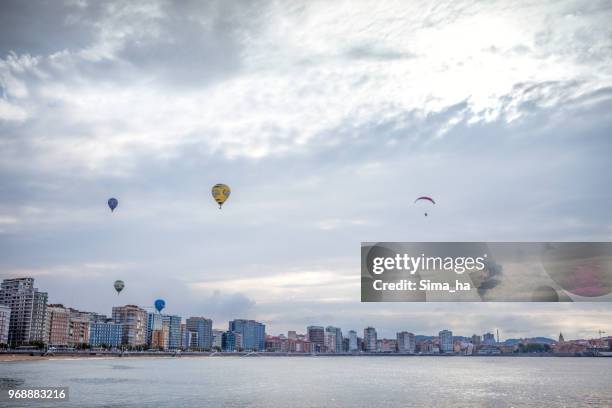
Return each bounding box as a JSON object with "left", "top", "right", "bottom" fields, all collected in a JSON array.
[{"left": 0, "top": 278, "right": 47, "bottom": 347}]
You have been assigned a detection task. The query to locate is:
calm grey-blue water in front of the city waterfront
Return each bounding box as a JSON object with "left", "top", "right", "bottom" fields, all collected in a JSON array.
[{"left": 0, "top": 357, "right": 612, "bottom": 408}]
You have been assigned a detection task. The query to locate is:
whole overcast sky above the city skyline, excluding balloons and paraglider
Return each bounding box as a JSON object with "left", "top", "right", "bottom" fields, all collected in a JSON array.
[{"left": 0, "top": 0, "right": 612, "bottom": 338}]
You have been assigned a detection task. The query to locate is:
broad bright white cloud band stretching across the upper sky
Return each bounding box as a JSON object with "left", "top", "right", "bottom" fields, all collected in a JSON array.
[{"left": 0, "top": 2, "right": 612, "bottom": 172}]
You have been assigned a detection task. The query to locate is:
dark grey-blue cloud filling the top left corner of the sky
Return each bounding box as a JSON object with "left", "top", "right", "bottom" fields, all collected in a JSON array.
[{"left": 0, "top": 1, "right": 266, "bottom": 94}]
